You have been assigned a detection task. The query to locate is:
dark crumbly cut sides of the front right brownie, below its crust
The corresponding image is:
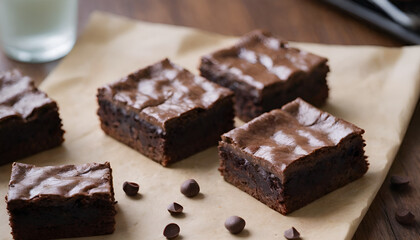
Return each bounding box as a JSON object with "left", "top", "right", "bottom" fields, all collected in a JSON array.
[{"left": 219, "top": 135, "right": 367, "bottom": 215}]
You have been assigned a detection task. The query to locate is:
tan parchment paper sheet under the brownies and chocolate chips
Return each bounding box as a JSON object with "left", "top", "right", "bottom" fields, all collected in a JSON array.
[{"left": 0, "top": 13, "right": 420, "bottom": 240}]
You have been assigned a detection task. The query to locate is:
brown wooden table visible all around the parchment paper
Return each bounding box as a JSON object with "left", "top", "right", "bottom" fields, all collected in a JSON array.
[{"left": 0, "top": 0, "right": 420, "bottom": 240}]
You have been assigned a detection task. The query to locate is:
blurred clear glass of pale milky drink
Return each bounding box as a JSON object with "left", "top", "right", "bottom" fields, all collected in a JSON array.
[{"left": 0, "top": 0, "right": 77, "bottom": 62}]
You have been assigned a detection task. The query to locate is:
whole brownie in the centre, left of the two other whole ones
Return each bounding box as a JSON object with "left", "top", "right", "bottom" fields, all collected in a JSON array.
[{"left": 97, "top": 59, "right": 234, "bottom": 166}]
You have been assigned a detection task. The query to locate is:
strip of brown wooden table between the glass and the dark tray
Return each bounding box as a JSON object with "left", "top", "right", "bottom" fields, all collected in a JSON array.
[{"left": 75, "top": 0, "right": 420, "bottom": 46}]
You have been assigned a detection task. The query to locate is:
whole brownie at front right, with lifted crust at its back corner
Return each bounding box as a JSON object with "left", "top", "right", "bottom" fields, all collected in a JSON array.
[{"left": 219, "top": 99, "right": 368, "bottom": 214}]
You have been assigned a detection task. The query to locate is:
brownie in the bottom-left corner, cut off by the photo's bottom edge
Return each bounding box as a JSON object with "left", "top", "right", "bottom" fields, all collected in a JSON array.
[{"left": 6, "top": 162, "right": 116, "bottom": 240}]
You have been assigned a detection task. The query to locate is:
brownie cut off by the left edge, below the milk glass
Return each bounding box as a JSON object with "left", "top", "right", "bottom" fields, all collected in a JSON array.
[{"left": 0, "top": 70, "right": 64, "bottom": 164}]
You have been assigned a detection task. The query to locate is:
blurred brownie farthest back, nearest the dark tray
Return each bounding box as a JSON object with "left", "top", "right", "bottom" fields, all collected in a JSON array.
[{"left": 200, "top": 30, "right": 329, "bottom": 121}]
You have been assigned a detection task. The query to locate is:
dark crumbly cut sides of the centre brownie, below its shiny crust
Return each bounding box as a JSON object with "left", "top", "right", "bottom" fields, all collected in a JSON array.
[{"left": 98, "top": 94, "right": 234, "bottom": 167}]
